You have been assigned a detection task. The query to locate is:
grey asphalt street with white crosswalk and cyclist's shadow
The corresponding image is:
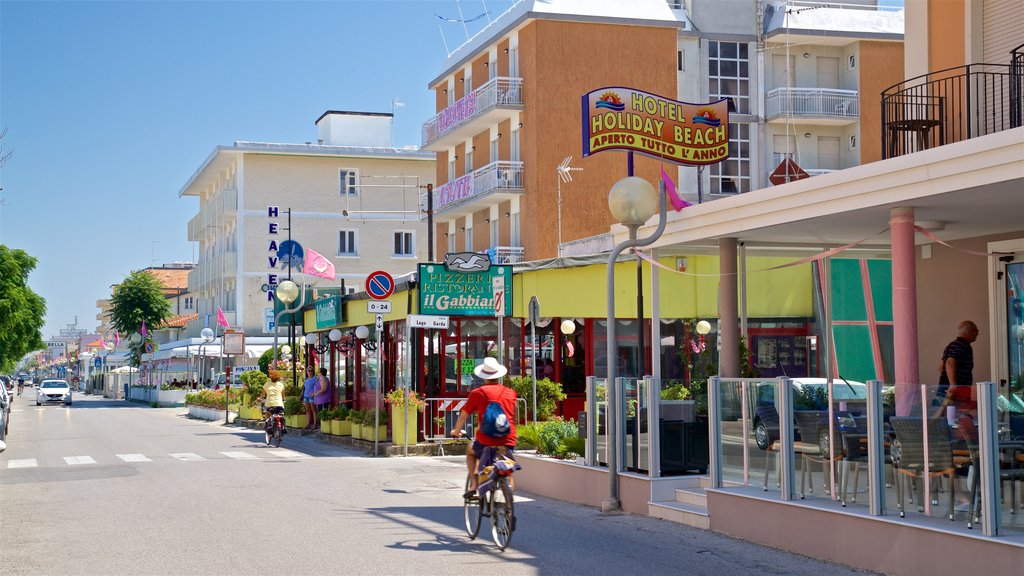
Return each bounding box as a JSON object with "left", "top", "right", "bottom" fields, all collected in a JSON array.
[{"left": 0, "top": 395, "right": 863, "bottom": 576}]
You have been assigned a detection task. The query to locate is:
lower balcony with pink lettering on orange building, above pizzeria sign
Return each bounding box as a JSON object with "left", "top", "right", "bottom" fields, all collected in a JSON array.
[{"left": 420, "top": 160, "right": 525, "bottom": 219}]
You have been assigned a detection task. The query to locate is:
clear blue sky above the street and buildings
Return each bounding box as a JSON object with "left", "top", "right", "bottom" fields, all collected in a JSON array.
[{"left": 0, "top": 0, "right": 511, "bottom": 337}]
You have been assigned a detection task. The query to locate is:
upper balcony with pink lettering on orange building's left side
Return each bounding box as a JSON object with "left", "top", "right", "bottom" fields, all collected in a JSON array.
[{"left": 423, "top": 78, "right": 522, "bottom": 151}]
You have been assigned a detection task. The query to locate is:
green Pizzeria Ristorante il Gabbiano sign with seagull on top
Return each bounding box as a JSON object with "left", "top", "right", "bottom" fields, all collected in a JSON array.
[{"left": 419, "top": 263, "right": 512, "bottom": 318}]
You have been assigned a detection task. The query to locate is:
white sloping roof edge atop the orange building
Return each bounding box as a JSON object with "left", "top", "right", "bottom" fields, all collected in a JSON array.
[{"left": 427, "top": 0, "right": 690, "bottom": 89}]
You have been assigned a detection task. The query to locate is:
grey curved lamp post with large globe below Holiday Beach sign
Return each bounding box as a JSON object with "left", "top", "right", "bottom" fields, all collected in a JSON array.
[{"left": 601, "top": 176, "right": 666, "bottom": 511}]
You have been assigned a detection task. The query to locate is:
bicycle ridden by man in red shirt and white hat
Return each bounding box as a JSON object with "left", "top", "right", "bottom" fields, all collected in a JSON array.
[{"left": 463, "top": 436, "right": 519, "bottom": 550}]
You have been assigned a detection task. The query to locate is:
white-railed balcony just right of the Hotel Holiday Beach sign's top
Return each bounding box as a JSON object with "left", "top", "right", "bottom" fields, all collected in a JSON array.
[{"left": 765, "top": 88, "right": 860, "bottom": 126}]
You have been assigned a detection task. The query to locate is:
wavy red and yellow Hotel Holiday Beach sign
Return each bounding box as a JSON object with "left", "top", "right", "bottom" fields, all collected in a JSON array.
[{"left": 582, "top": 86, "right": 729, "bottom": 165}]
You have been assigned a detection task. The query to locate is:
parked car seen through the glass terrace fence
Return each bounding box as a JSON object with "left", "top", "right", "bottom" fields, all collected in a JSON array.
[{"left": 754, "top": 378, "right": 867, "bottom": 454}]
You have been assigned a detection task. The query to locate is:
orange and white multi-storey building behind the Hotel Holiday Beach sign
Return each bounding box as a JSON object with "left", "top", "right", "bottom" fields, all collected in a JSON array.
[{"left": 423, "top": 0, "right": 903, "bottom": 262}]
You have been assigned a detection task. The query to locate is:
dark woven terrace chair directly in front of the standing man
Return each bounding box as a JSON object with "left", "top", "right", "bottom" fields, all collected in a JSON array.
[{"left": 889, "top": 416, "right": 973, "bottom": 520}]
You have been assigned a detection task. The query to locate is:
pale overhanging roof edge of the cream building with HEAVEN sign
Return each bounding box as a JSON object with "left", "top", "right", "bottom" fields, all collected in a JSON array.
[{"left": 178, "top": 140, "right": 435, "bottom": 198}]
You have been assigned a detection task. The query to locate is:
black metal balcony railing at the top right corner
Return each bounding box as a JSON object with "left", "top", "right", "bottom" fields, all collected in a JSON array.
[{"left": 882, "top": 50, "right": 1024, "bottom": 158}]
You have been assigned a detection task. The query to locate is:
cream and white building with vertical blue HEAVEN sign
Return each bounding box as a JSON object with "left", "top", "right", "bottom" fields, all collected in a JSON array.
[{"left": 179, "top": 111, "right": 434, "bottom": 337}]
